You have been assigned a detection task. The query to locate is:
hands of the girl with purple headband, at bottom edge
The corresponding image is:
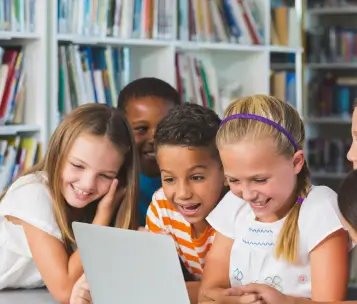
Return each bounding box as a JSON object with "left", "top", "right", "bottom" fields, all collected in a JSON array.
[{"left": 200, "top": 287, "right": 262, "bottom": 304}]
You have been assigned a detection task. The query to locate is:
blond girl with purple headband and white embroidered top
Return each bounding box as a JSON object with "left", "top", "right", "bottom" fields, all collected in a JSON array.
[{"left": 201, "top": 95, "right": 348, "bottom": 302}]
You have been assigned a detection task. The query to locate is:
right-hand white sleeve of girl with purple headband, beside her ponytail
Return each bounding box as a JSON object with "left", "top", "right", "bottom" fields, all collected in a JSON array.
[{"left": 299, "top": 186, "right": 344, "bottom": 252}]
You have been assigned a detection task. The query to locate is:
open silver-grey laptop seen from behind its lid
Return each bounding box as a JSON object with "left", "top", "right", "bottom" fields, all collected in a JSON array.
[{"left": 72, "top": 222, "right": 190, "bottom": 304}]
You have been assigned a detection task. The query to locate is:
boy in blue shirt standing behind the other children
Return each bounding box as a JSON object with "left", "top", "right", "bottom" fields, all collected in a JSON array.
[{"left": 118, "top": 77, "right": 180, "bottom": 226}]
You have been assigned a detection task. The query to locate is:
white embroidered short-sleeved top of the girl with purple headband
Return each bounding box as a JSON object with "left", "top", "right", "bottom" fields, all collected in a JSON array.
[{"left": 207, "top": 186, "right": 343, "bottom": 298}]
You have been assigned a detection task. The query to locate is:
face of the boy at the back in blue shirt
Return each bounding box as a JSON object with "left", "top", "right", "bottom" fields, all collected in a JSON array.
[{"left": 125, "top": 97, "right": 174, "bottom": 177}]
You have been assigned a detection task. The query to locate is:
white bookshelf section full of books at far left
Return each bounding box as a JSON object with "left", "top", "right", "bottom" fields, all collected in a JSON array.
[{"left": 0, "top": 0, "right": 50, "bottom": 192}]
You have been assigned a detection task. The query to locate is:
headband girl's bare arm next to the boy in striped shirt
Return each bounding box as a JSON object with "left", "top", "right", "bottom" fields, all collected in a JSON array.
[{"left": 198, "top": 232, "right": 234, "bottom": 303}]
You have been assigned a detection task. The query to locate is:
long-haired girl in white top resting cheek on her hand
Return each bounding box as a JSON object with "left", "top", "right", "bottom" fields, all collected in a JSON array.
[{"left": 0, "top": 104, "right": 139, "bottom": 303}]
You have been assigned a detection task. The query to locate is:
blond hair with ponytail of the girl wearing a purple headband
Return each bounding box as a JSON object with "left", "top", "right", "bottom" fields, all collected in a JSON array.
[{"left": 217, "top": 95, "right": 311, "bottom": 262}]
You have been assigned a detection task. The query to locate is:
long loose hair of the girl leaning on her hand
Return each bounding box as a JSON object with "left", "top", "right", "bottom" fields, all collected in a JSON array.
[{"left": 0, "top": 104, "right": 139, "bottom": 250}]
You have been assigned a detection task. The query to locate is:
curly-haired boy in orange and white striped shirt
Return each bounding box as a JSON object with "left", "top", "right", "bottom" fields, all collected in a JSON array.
[{"left": 146, "top": 103, "right": 226, "bottom": 303}]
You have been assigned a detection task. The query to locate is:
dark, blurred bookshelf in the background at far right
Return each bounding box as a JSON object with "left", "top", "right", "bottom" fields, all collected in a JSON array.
[{"left": 304, "top": 0, "right": 357, "bottom": 190}]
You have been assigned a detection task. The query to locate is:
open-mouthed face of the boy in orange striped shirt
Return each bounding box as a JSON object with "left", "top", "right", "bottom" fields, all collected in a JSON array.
[{"left": 157, "top": 145, "right": 224, "bottom": 225}]
